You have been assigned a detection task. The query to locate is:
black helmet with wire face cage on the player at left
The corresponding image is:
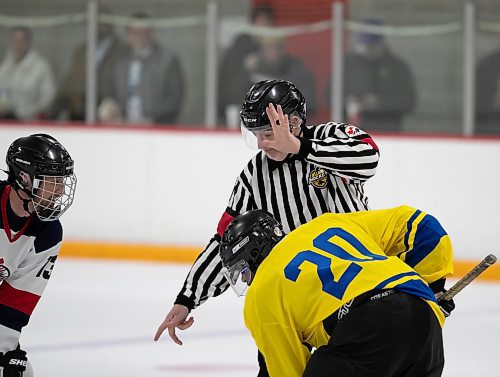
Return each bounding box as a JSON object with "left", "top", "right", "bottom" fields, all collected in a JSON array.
[{"left": 6, "top": 134, "right": 76, "bottom": 221}]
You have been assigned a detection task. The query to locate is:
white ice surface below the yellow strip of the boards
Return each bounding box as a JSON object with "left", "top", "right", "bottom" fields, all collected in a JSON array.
[{"left": 21, "top": 259, "right": 500, "bottom": 377}]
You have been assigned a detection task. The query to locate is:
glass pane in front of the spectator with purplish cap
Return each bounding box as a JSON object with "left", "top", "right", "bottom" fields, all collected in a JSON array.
[{"left": 339, "top": 0, "right": 463, "bottom": 133}]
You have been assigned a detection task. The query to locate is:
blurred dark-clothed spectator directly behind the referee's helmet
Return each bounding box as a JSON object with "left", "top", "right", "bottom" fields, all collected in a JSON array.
[{"left": 219, "top": 6, "right": 316, "bottom": 126}]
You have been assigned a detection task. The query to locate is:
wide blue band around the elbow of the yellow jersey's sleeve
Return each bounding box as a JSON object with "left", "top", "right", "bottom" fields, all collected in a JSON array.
[{"left": 405, "top": 215, "right": 446, "bottom": 267}]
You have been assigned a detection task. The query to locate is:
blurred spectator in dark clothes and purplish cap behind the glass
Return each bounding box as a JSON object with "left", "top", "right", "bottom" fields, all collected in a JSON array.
[{"left": 328, "top": 20, "right": 416, "bottom": 131}]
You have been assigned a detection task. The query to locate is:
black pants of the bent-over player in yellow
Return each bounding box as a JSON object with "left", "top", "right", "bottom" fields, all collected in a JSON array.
[{"left": 303, "top": 291, "right": 444, "bottom": 377}]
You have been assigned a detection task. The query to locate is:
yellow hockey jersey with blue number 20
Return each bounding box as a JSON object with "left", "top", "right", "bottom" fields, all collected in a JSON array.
[{"left": 244, "top": 206, "right": 453, "bottom": 377}]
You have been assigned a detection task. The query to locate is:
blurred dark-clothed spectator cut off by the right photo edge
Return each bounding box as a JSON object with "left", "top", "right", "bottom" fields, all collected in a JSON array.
[{"left": 476, "top": 45, "right": 500, "bottom": 134}]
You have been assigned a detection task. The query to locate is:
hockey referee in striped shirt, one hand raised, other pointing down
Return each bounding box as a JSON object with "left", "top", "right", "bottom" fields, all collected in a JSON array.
[{"left": 155, "top": 80, "right": 379, "bottom": 345}]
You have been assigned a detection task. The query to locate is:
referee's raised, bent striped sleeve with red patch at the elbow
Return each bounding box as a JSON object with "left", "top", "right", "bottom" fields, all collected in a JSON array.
[{"left": 298, "top": 122, "right": 379, "bottom": 181}]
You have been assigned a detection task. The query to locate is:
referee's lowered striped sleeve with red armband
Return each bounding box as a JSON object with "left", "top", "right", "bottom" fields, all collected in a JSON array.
[{"left": 175, "top": 163, "right": 255, "bottom": 310}]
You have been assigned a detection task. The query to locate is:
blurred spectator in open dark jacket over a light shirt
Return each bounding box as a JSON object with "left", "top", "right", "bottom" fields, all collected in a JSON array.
[{"left": 98, "top": 13, "right": 185, "bottom": 124}]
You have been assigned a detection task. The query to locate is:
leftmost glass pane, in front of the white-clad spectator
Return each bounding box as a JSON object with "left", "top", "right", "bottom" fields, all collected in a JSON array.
[{"left": 0, "top": 0, "right": 86, "bottom": 121}]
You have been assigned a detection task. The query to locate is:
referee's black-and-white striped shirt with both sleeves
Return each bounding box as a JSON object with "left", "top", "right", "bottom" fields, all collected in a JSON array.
[{"left": 175, "top": 122, "right": 379, "bottom": 309}]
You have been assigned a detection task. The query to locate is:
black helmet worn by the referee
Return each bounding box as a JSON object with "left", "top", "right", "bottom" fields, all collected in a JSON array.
[{"left": 240, "top": 80, "right": 306, "bottom": 131}]
